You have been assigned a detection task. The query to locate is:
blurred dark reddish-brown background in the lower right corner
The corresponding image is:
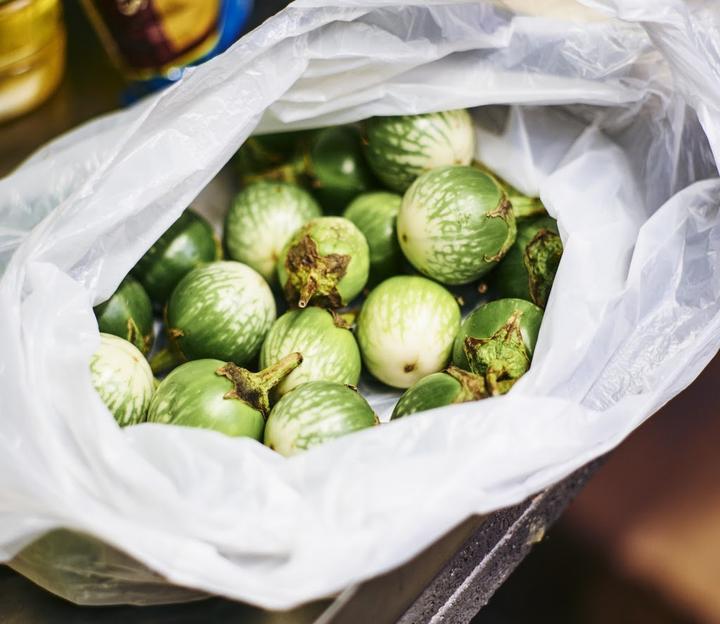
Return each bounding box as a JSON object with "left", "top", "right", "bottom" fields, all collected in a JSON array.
[{"left": 476, "top": 358, "right": 720, "bottom": 624}]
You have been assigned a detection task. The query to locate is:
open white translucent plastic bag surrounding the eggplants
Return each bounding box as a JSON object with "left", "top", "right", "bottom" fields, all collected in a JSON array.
[{"left": 0, "top": 0, "right": 720, "bottom": 608}]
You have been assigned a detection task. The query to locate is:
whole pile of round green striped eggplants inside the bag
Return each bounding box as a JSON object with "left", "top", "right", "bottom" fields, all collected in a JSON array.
[{"left": 91, "top": 110, "right": 562, "bottom": 455}]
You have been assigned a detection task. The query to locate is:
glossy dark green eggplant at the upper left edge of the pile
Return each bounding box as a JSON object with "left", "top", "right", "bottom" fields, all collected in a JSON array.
[{"left": 132, "top": 210, "right": 220, "bottom": 305}]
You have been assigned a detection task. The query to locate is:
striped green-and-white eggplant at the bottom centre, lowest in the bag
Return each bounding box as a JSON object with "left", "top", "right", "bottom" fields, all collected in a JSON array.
[{"left": 265, "top": 381, "right": 378, "bottom": 457}]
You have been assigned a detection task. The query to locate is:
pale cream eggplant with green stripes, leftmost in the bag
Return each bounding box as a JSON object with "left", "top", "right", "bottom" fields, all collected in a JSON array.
[{"left": 90, "top": 333, "right": 155, "bottom": 427}]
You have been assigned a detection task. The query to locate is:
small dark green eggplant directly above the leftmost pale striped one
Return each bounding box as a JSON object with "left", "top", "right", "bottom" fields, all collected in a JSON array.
[{"left": 95, "top": 276, "right": 155, "bottom": 355}]
